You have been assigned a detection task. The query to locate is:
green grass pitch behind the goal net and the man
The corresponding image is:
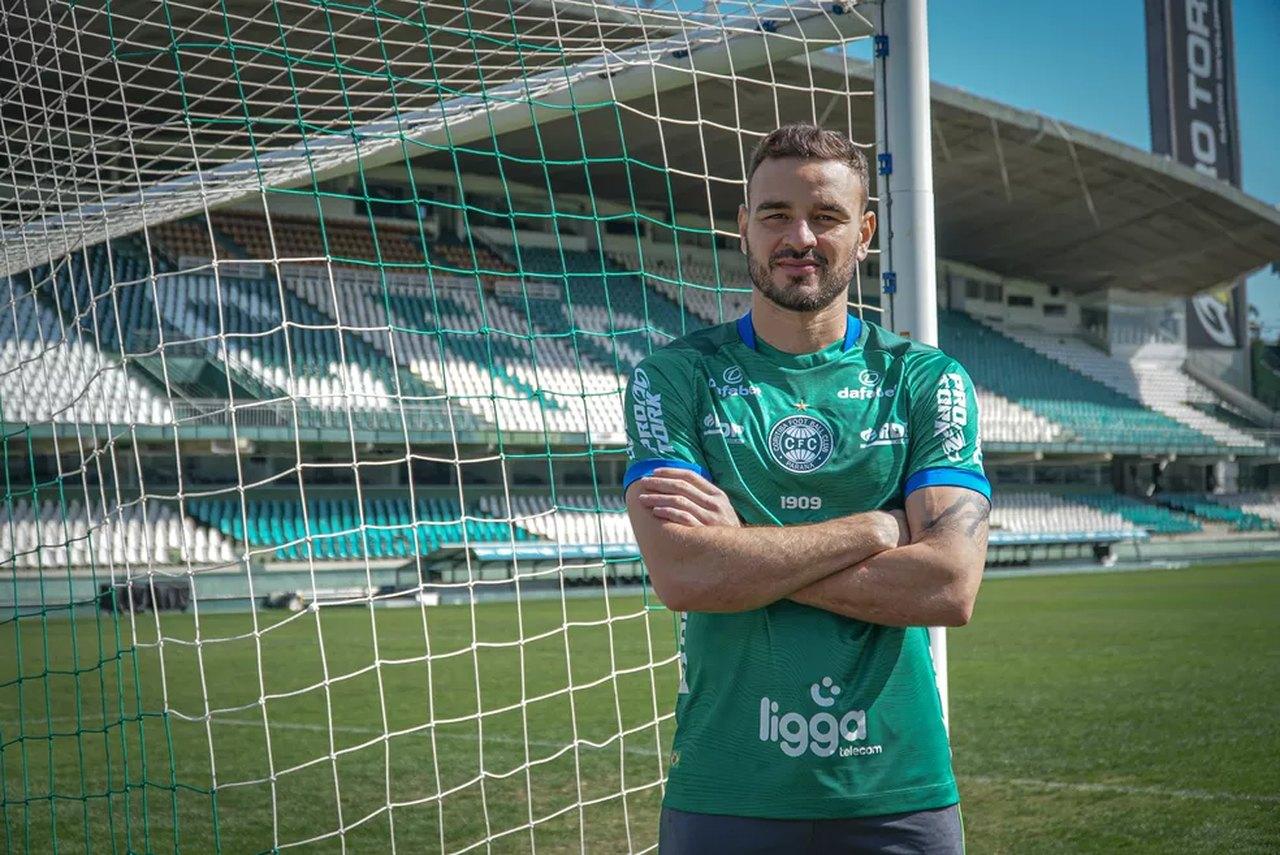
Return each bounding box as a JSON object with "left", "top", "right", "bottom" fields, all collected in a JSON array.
[{"left": 0, "top": 564, "right": 1280, "bottom": 852}]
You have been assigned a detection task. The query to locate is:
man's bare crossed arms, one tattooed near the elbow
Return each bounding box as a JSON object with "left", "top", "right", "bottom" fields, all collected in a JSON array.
[{"left": 627, "top": 468, "right": 989, "bottom": 626}]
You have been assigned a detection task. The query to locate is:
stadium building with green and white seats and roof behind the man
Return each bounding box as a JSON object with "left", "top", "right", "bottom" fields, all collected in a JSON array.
[{"left": 4, "top": 35, "right": 1280, "bottom": 602}]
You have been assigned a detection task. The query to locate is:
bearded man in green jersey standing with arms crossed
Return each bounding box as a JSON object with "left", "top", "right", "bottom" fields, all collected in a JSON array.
[{"left": 623, "top": 125, "right": 991, "bottom": 855}]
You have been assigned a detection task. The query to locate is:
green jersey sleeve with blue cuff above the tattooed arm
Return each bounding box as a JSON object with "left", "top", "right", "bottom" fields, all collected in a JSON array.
[{"left": 902, "top": 357, "right": 991, "bottom": 500}]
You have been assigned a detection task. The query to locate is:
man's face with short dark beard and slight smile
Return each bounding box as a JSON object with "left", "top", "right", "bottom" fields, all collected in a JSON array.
[{"left": 737, "top": 157, "right": 876, "bottom": 312}]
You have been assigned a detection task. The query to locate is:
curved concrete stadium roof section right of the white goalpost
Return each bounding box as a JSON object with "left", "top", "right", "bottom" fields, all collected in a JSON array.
[{"left": 896, "top": 56, "right": 1280, "bottom": 294}]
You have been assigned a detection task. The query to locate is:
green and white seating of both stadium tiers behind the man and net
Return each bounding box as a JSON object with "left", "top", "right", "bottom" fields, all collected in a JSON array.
[{"left": 0, "top": 223, "right": 1259, "bottom": 567}]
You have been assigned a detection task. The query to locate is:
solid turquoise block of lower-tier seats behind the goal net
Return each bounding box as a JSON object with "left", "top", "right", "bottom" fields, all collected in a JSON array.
[{"left": 188, "top": 497, "right": 534, "bottom": 561}]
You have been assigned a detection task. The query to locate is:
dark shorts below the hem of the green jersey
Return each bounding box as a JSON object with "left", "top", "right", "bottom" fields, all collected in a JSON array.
[{"left": 658, "top": 805, "right": 964, "bottom": 855}]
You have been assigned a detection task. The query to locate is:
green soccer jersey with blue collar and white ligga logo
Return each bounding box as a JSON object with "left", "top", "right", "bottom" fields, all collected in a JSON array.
[{"left": 623, "top": 314, "right": 991, "bottom": 819}]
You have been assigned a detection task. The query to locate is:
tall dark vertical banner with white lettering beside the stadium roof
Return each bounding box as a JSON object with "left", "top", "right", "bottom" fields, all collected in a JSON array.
[{"left": 1147, "top": 0, "right": 1248, "bottom": 348}]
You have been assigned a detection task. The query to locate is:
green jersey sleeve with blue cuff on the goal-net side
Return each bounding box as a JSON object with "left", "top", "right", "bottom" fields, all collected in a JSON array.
[{"left": 622, "top": 351, "right": 710, "bottom": 494}]
